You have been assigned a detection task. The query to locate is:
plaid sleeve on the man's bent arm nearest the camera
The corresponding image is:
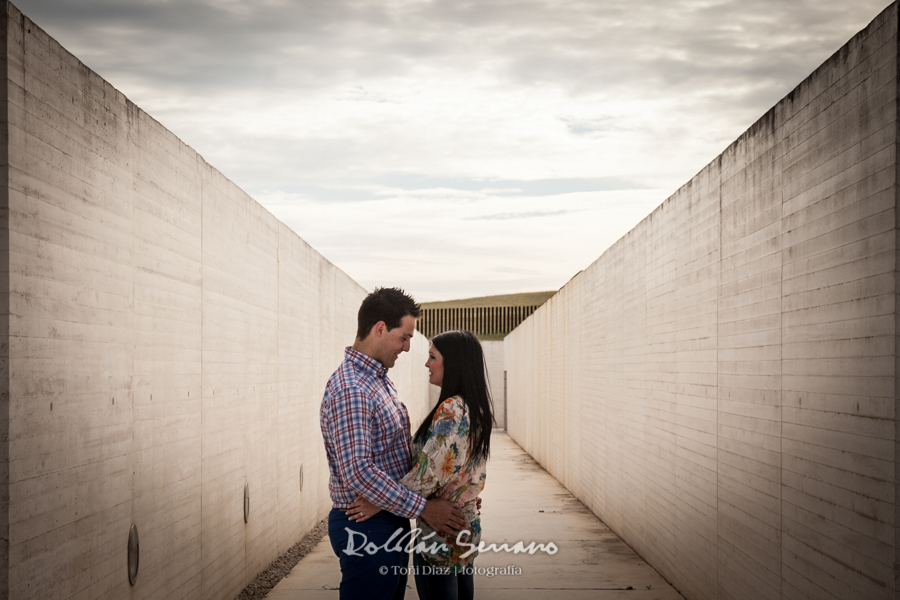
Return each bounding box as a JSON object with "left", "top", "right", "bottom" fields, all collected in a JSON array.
[{"left": 330, "top": 386, "right": 425, "bottom": 519}]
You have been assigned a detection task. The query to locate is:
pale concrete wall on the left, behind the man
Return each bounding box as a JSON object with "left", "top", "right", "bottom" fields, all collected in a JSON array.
[{"left": 0, "top": 3, "right": 428, "bottom": 600}]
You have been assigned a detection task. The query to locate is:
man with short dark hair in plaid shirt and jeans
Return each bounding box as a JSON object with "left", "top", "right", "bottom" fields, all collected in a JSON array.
[{"left": 319, "top": 288, "right": 466, "bottom": 600}]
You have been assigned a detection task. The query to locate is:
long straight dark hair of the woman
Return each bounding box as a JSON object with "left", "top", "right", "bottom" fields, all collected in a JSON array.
[{"left": 415, "top": 331, "right": 494, "bottom": 458}]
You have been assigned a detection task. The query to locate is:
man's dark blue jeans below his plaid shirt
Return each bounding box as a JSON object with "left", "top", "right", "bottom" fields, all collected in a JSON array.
[{"left": 328, "top": 508, "right": 409, "bottom": 600}]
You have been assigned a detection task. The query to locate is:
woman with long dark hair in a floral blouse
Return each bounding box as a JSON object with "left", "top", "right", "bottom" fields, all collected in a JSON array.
[{"left": 348, "top": 331, "right": 493, "bottom": 600}]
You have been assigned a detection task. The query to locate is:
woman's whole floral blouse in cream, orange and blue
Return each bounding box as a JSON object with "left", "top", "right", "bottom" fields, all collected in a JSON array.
[{"left": 400, "top": 396, "right": 487, "bottom": 573}]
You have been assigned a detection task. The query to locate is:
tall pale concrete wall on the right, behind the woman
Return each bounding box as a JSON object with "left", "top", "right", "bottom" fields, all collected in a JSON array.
[{"left": 506, "top": 4, "right": 900, "bottom": 600}]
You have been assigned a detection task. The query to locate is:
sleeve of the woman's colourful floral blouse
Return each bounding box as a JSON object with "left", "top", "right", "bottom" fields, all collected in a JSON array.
[{"left": 400, "top": 397, "right": 470, "bottom": 498}]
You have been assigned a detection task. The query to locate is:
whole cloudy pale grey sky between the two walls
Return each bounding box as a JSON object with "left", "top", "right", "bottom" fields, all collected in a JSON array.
[{"left": 13, "top": 0, "right": 887, "bottom": 301}]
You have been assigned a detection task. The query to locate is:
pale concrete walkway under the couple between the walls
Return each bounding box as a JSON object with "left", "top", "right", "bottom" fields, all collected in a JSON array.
[{"left": 268, "top": 431, "right": 683, "bottom": 600}]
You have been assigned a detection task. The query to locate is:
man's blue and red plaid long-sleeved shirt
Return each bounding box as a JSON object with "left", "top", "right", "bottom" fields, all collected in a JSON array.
[{"left": 319, "top": 347, "right": 425, "bottom": 519}]
